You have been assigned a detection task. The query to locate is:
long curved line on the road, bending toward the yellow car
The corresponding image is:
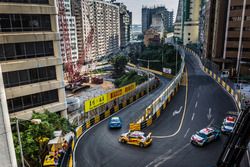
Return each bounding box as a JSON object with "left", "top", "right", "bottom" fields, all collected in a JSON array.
[{"left": 152, "top": 69, "right": 188, "bottom": 139}]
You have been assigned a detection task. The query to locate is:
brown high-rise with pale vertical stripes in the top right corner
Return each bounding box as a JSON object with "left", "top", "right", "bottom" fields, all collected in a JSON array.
[{"left": 203, "top": 0, "right": 250, "bottom": 77}]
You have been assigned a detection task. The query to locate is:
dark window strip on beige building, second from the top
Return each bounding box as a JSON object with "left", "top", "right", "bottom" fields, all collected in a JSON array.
[{"left": 0, "top": 14, "right": 51, "bottom": 32}]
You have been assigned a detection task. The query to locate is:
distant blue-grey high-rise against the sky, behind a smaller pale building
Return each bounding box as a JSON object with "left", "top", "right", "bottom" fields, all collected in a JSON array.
[{"left": 142, "top": 6, "right": 174, "bottom": 33}]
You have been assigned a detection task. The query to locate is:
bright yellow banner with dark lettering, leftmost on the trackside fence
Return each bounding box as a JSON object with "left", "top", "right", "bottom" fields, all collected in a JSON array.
[{"left": 84, "top": 94, "right": 108, "bottom": 112}]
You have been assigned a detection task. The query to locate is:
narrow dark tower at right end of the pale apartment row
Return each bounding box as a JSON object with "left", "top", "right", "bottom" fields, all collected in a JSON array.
[{"left": 114, "top": 3, "right": 132, "bottom": 48}]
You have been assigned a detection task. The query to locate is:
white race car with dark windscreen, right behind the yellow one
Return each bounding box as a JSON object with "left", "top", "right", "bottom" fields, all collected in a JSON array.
[{"left": 191, "top": 127, "right": 221, "bottom": 146}]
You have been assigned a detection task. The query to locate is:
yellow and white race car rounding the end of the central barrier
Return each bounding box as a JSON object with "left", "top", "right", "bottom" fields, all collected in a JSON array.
[{"left": 119, "top": 131, "right": 152, "bottom": 147}]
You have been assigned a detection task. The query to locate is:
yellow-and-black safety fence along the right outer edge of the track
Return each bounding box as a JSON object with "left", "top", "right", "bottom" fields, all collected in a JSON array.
[{"left": 184, "top": 48, "right": 241, "bottom": 109}]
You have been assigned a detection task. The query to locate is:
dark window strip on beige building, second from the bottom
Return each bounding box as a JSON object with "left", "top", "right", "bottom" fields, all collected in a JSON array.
[{"left": 3, "top": 66, "right": 56, "bottom": 88}]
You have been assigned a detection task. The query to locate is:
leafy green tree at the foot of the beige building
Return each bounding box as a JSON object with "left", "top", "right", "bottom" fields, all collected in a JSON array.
[{"left": 13, "top": 111, "right": 71, "bottom": 167}]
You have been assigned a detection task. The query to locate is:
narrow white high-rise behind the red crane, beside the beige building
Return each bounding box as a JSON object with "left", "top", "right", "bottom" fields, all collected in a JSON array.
[{"left": 57, "top": 0, "right": 78, "bottom": 63}]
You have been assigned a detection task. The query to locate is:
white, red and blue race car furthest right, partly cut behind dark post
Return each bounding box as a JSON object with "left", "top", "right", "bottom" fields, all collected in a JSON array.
[{"left": 221, "top": 116, "right": 237, "bottom": 134}]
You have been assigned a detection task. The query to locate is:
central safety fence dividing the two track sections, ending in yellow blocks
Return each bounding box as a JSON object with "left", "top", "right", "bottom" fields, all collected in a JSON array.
[{"left": 129, "top": 47, "right": 185, "bottom": 131}]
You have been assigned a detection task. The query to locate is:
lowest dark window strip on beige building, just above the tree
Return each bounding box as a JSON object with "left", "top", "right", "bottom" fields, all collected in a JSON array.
[{"left": 7, "top": 89, "right": 59, "bottom": 113}]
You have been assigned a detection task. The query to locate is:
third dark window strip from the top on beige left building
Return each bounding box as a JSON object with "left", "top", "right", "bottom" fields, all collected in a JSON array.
[{"left": 0, "top": 41, "right": 54, "bottom": 61}]
